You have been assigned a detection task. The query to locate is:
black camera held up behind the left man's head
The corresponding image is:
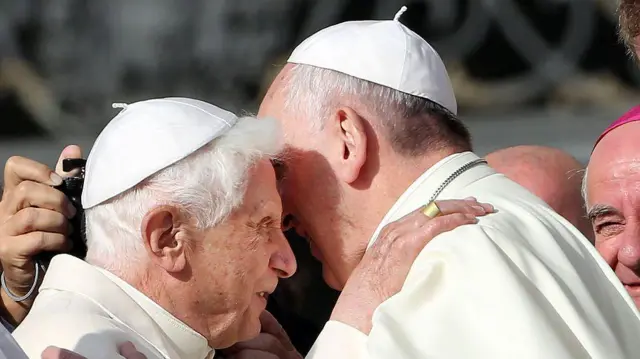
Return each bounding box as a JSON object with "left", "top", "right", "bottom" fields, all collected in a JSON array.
[{"left": 38, "top": 158, "right": 87, "bottom": 265}]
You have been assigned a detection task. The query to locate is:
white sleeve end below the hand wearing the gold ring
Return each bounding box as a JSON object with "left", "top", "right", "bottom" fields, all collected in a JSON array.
[{"left": 306, "top": 320, "right": 367, "bottom": 359}]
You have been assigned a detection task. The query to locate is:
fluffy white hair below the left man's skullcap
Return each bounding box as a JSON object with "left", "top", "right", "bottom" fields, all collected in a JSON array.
[{"left": 85, "top": 117, "right": 282, "bottom": 273}]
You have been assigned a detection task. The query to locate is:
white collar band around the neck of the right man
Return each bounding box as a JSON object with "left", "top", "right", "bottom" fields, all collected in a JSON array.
[{"left": 367, "top": 152, "right": 496, "bottom": 248}]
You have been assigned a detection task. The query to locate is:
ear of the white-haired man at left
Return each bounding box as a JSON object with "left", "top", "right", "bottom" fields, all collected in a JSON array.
[{"left": 141, "top": 206, "right": 188, "bottom": 273}]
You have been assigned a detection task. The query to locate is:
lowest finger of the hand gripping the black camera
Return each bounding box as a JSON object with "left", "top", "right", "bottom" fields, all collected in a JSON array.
[{"left": 0, "top": 232, "right": 73, "bottom": 260}]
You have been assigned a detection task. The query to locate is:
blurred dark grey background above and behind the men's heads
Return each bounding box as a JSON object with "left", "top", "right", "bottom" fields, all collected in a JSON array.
[{"left": 0, "top": 0, "right": 640, "bottom": 164}]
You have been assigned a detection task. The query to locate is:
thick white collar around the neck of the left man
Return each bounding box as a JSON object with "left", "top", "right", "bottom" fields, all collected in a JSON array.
[{"left": 40, "top": 254, "right": 214, "bottom": 359}]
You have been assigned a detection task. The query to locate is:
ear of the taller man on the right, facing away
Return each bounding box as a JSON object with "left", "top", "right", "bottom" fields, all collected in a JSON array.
[{"left": 336, "top": 108, "right": 367, "bottom": 184}]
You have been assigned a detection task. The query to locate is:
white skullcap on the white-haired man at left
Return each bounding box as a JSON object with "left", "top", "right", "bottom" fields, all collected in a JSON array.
[{"left": 82, "top": 98, "right": 238, "bottom": 209}]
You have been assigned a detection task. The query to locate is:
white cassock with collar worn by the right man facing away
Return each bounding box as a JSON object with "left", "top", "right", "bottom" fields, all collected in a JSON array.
[{"left": 307, "top": 152, "right": 640, "bottom": 359}]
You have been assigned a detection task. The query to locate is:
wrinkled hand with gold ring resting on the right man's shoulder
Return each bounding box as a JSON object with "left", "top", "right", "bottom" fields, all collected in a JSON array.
[{"left": 331, "top": 198, "right": 495, "bottom": 334}]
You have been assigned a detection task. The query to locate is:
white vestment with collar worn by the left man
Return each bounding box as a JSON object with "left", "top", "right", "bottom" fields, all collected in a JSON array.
[{"left": 13, "top": 254, "right": 213, "bottom": 359}]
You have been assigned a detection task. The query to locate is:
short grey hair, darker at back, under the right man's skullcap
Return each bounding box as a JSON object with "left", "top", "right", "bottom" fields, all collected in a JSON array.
[{"left": 285, "top": 64, "right": 471, "bottom": 156}]
